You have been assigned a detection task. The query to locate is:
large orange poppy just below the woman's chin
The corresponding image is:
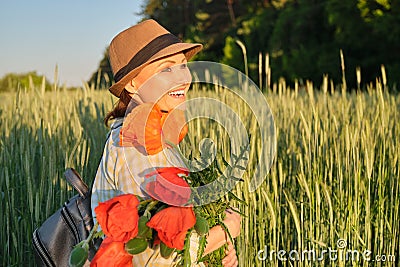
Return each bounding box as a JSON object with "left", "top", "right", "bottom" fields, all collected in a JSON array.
[{"left": 120, "top": 103, "right": 187, "bottom": 155}]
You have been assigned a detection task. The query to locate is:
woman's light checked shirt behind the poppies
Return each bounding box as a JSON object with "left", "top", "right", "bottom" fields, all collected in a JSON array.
[{"left": 91, "top": 118, "right": 204, "bottom": 267}]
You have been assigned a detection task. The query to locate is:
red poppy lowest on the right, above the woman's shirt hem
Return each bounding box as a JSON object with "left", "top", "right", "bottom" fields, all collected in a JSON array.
[{"left": 147, "top": 207, "right": 196, "bottom": 250}]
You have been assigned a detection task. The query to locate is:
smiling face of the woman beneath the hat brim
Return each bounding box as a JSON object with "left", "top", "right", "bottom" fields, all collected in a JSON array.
[{"left": 126, "top": 53, "right": 191, "bottom": 111}]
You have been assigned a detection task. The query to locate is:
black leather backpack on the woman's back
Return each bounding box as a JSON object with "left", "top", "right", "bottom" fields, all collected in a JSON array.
[{"left": 32, "top": 168, "right": 100, "bottom": 267}]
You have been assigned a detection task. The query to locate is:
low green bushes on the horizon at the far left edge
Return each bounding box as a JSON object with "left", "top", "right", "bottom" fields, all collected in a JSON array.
[{"left": 0, "top": 71, "right": 52, "bottom": 92}]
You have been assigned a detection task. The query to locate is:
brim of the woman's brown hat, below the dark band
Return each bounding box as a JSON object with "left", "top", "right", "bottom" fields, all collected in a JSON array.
[{"left": 109, "top": 43, "right": 203, "bottom": 97}]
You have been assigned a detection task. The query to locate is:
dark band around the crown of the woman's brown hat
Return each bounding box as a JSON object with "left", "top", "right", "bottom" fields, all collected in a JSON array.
[{"left": 114, "top": 33, "right": 181, "bottom": 82}]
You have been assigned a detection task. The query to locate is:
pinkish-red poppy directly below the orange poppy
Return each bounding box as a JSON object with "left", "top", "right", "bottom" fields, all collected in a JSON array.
[{"left": 146, "top": 167, "right": 191, "bottom": 206}]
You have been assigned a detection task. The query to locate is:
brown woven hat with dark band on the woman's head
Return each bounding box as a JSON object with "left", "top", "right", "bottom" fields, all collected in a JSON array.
[{"left": 109, "top": 19, "right": 203, "bottom": 97}]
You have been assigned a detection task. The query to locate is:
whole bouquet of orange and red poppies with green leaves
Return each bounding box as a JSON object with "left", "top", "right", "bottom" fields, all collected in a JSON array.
[{"left": 70, "top": 104, "right": 246, "bottom": 266}]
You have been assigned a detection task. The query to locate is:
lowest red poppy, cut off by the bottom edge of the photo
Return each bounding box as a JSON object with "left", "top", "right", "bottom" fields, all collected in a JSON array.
[{"left": 90, "top": 237, "right": 133, "bottom": 267}]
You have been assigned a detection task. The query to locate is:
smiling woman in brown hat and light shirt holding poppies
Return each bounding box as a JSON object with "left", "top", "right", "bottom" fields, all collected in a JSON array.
[{"left": 92, "top": 20, "right": 240, "bottom": 267}]
